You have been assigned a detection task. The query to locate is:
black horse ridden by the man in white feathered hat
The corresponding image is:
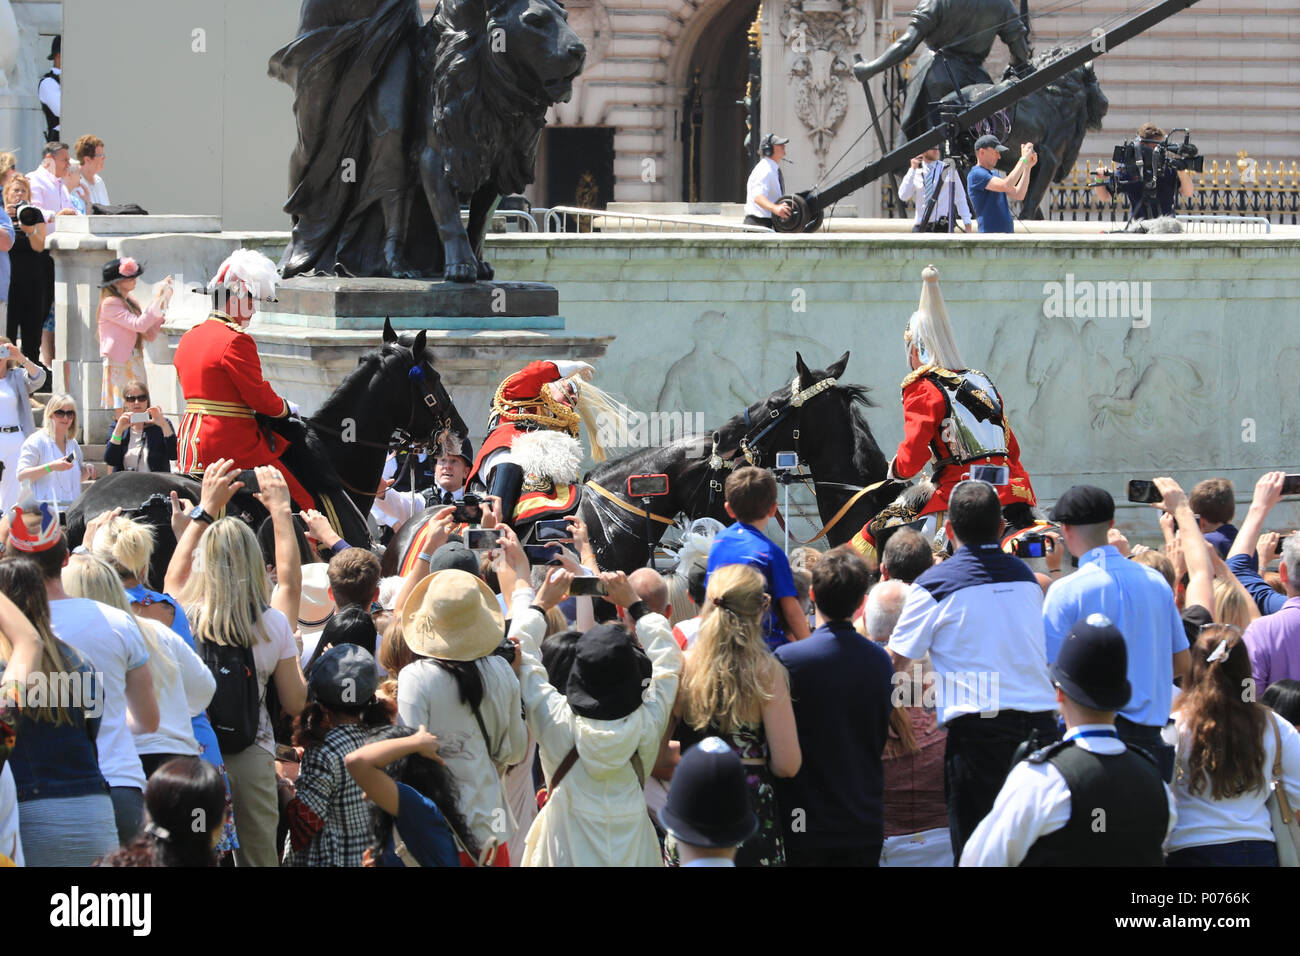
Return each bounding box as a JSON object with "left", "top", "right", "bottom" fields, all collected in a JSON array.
[{"left": 68, "top": 321, "right": 467, "bottom": 587}]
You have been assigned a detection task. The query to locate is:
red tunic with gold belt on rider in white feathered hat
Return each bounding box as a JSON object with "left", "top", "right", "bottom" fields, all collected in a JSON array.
[{"left": 176, "top": 312, "right": 315, "bottom": 509}]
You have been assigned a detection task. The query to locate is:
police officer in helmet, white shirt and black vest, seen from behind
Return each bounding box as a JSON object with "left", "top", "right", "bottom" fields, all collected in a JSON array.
[{"left": 961, "top": 614, "right": 1177, "bottom": 866}]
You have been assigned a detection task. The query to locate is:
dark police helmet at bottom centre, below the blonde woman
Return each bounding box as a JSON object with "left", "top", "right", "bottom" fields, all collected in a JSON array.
[{"left": 659, "top": 737, "right": 758, "bottom": 847}]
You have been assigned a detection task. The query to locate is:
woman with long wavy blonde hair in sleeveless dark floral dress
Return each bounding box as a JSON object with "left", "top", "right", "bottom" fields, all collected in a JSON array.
[{"left": 664, "top": 564, "right": 802, "bottom": 866}]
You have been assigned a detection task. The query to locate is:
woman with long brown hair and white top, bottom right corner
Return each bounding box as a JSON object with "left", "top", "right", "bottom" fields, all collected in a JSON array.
[{"left": 1166, "top": 624, "right": 1300, "bottom": 866}]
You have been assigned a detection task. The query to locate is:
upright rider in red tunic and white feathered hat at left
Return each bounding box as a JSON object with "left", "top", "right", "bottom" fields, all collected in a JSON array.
[{"left": 176, "top": 248, "right": 315, "bottom": 509}]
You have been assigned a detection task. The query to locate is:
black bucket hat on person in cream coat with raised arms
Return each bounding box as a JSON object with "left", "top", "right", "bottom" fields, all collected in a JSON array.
[{"left": 564, "top": 622, "right": 650, "bottom": 721}]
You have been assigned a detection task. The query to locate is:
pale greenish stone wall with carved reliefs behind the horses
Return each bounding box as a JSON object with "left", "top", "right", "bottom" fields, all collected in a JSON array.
[{"left": 488, "top": 227, "right": 1300, "bottom": 533}]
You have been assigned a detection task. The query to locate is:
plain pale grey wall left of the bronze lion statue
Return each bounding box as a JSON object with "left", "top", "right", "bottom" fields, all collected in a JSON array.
[{"left": 64, "top": 0, "right": 299, "bottom": 230}]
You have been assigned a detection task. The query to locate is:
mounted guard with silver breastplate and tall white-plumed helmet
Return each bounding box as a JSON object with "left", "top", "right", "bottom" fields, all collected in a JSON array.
[{"left": 853, "top": 265, "right": 1037, "bottom": 557}]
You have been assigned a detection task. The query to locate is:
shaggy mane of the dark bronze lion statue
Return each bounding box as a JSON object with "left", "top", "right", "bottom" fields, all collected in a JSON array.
[{"left": 421, "top": 0, "right": 550, "bottom": 195}]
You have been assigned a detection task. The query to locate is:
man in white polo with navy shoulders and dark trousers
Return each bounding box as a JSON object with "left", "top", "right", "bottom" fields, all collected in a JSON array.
[{"left": 887, "top": 481, "right": 1057, "bottom": 860}]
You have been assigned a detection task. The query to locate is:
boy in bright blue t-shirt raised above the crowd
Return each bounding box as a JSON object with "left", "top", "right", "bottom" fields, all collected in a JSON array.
[{"left": 706, "top": 466, "right": 809, "bottom": 650}]
